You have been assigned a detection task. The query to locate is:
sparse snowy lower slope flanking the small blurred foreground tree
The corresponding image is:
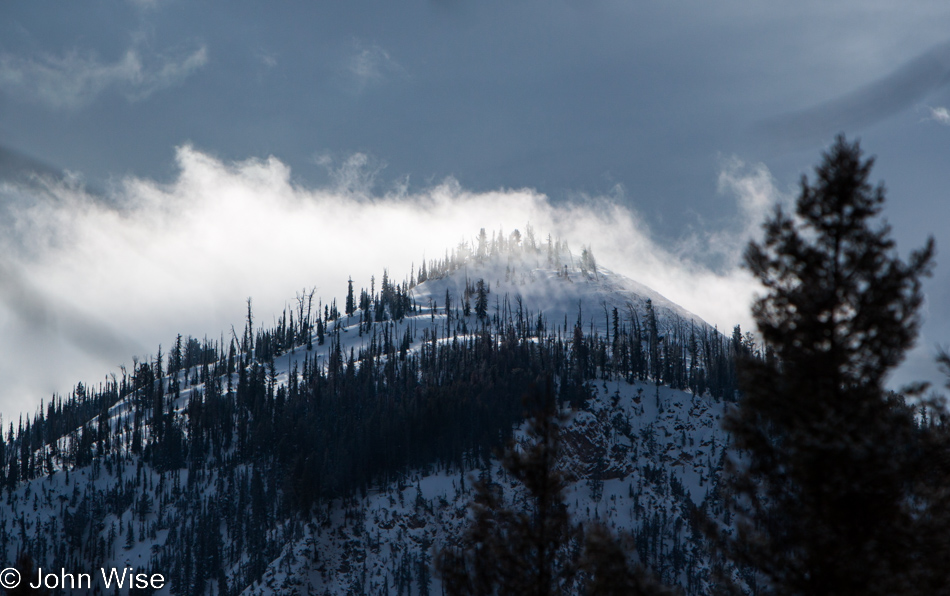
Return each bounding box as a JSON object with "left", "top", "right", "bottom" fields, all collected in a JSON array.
[{"left": 243, "top": 381, "right": 726, "bottom": 596}]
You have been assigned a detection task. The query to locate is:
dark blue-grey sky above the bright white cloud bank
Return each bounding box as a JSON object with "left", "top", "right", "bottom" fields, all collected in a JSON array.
[{"left": 0, "top": 0, "right": 950, "bottom": 412}]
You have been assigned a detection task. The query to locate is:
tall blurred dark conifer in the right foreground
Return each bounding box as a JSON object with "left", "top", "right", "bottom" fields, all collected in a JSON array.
[{"left": 723, "top": 137, "right": 950, "bottom": 595}]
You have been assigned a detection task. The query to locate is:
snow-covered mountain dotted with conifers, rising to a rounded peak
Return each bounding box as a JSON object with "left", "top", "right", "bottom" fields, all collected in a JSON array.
[{"left": 0, "top": 232, "right": 735, "bottom": 594}]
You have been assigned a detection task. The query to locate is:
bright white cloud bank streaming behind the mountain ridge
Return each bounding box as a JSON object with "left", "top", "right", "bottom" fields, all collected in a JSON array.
[{"left": 0, "top": 146, "right": 783, "bottom": 420}]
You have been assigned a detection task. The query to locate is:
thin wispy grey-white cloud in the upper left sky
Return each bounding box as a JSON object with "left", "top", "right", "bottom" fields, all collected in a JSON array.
[{"left": 0, "top": 46, "right": 208, "bottom": 110}]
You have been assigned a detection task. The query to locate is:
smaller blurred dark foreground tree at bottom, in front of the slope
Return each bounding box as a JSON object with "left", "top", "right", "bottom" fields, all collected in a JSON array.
[{"left": 436, "top": 382, "right": 673, "bottom": 596}]
